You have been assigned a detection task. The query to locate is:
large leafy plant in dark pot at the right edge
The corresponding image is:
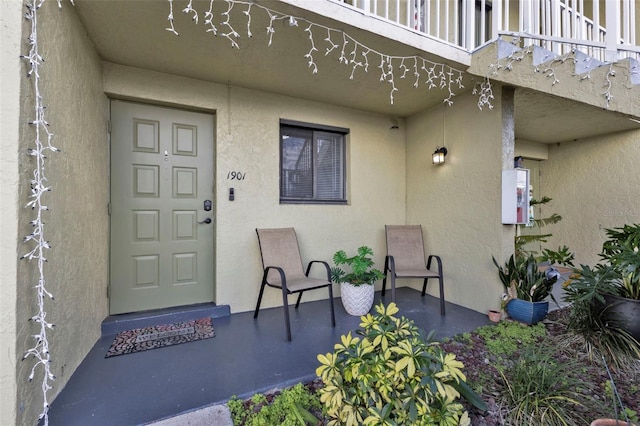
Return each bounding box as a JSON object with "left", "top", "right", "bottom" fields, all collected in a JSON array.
[{"left": 565, "top": 224, "right": 640, "bottom": 367}]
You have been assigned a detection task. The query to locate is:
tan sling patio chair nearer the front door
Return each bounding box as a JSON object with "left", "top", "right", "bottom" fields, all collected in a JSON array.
[{"left": 253, "top": 228, "right": 336, "bottom": 341}]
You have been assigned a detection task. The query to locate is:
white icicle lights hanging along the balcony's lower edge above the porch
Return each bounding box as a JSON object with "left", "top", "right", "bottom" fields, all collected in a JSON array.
[{"left": 167, "top": 0, "right": 464, "bottom": 105}]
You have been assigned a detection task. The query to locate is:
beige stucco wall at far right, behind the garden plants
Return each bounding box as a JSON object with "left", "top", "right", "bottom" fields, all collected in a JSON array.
[{"left": 540, "top": 130, "right": 640, "bottom": 266}]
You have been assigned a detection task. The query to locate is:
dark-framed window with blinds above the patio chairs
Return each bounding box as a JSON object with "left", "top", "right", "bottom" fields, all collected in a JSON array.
[{"left": 280, "top": 121, "right": 347, "bottom": 204}]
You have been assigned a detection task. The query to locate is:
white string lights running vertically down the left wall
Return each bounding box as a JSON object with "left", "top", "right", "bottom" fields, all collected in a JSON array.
[{"left": 21, "top": 0, "right": 73, "bottom": 426}]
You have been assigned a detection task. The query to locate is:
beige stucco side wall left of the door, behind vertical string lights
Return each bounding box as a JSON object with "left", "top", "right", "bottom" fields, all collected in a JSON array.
[{"left": 12, "top": 1, "right": 109, "bottom": 425}]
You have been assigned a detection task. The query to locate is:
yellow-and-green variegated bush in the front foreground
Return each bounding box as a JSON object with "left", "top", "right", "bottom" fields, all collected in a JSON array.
[{"left": 316, "top": 303, "right": 486, "bottom": 426}]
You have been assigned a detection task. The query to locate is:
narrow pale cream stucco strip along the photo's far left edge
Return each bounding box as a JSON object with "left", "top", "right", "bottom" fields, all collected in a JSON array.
[{"left": 0, "top": 0, "right": 24, "bottom": 422}]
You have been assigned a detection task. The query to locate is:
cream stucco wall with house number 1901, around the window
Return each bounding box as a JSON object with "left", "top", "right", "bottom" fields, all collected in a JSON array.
[{"left": 105, "top": 64, "right": 406, "bottom": 312}]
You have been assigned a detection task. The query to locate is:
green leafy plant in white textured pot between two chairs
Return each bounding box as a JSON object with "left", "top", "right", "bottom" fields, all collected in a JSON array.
[{"left": 331, "top": 246, "right": 384, "bottom": 316}]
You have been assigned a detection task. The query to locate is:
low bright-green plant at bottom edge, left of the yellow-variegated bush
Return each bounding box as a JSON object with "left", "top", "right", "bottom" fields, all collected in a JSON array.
[{"left": 227, "top": 383, "right": 322, "bottom": 426}]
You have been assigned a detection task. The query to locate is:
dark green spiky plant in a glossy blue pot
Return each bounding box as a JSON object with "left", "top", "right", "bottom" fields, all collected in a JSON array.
[{"left": 493, "top": 254, "right": 558, "bottom": 324}]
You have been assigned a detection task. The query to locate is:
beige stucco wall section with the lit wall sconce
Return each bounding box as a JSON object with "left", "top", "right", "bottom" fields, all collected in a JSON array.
[{"left": 407, "top": 88, "right": 513, "bottom": 312}]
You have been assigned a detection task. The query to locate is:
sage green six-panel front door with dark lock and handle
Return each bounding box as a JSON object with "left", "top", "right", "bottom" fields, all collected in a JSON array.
[{"left": 109, "top": 100, "right": 215, "bottom": 314}]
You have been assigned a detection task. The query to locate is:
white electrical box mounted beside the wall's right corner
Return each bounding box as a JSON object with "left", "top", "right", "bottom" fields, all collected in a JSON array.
[{"left": 502, "top": 169, "right": 530, "bottom": 225}]
